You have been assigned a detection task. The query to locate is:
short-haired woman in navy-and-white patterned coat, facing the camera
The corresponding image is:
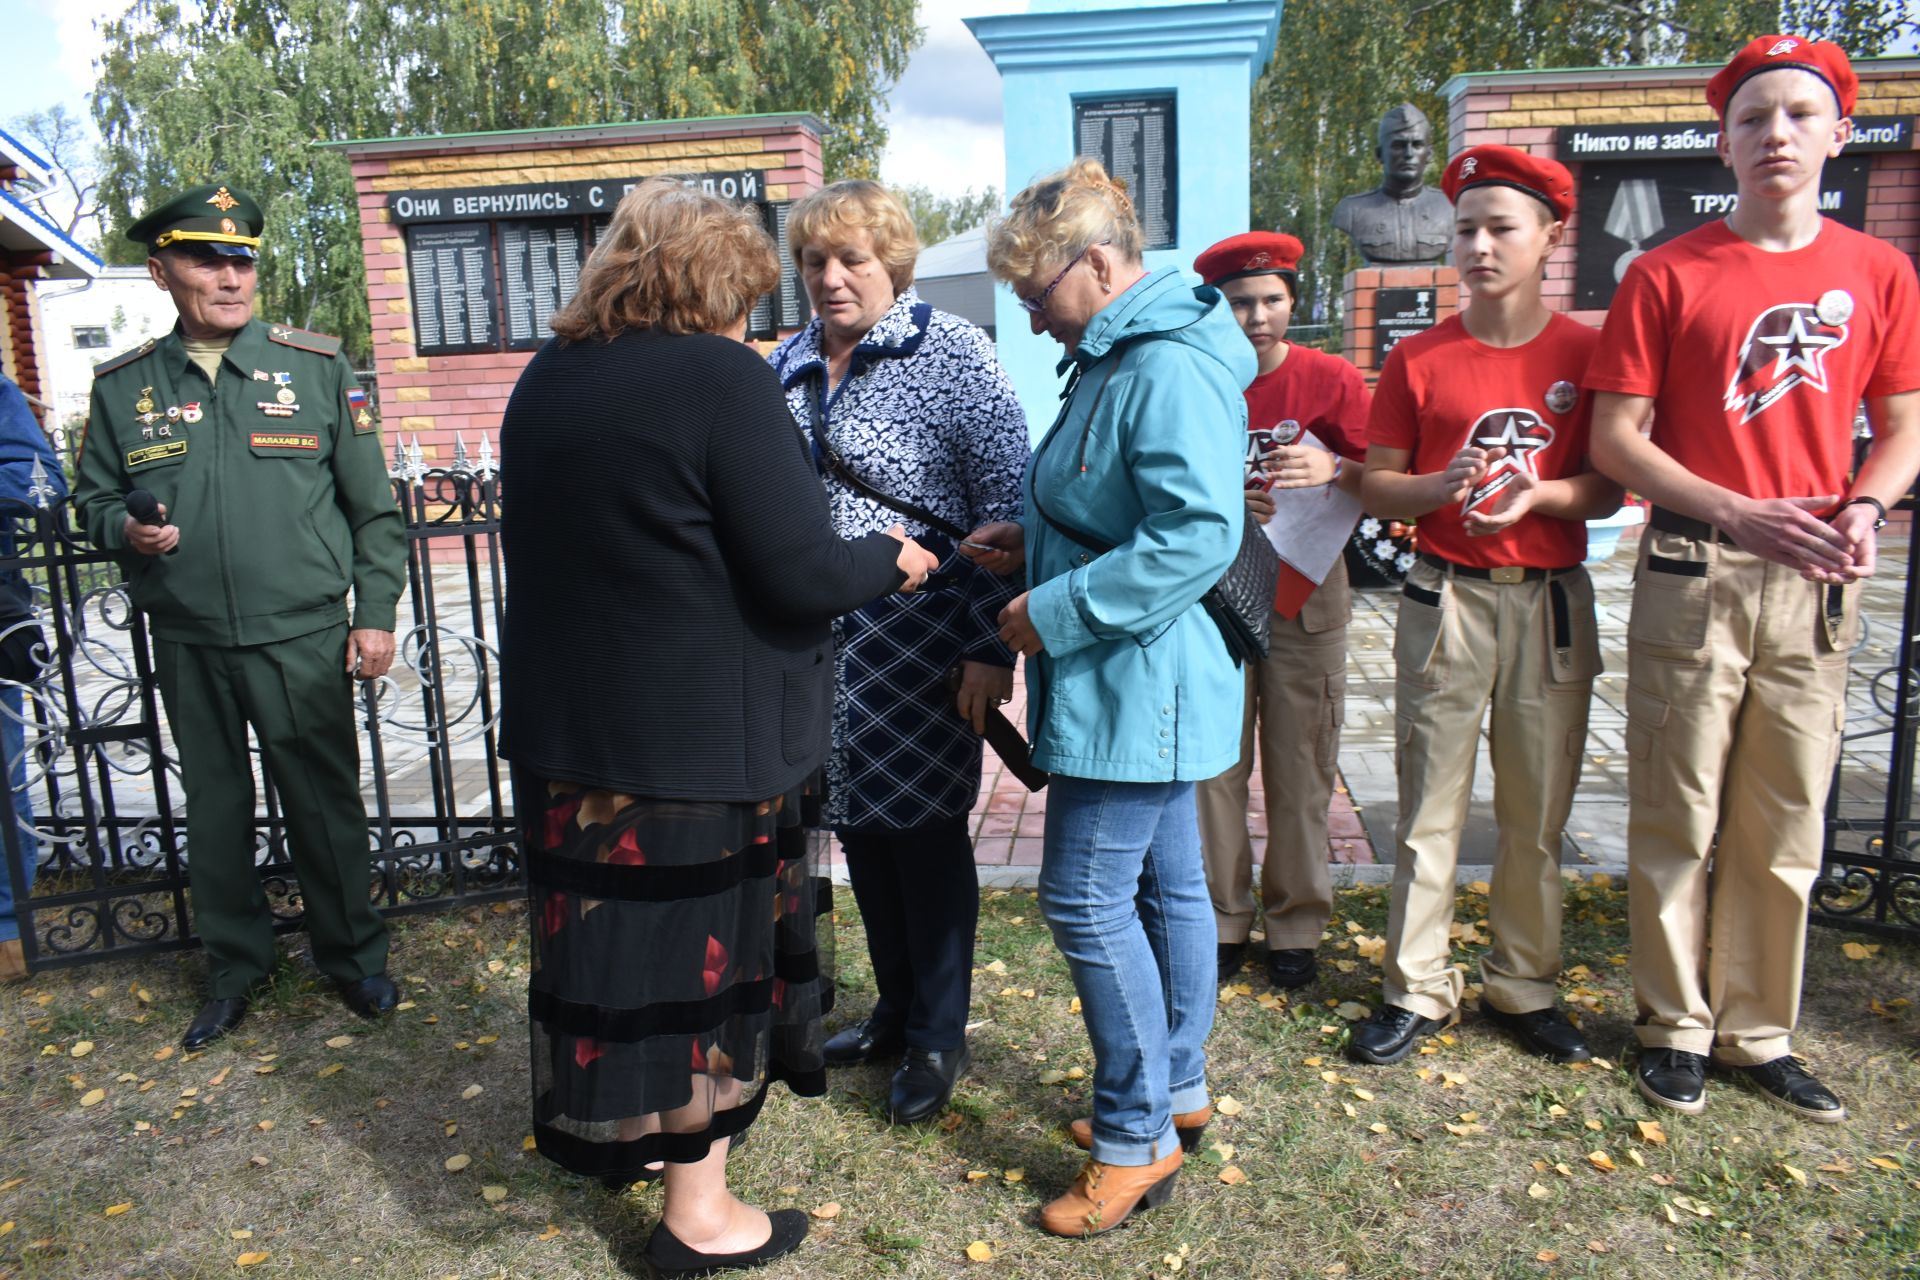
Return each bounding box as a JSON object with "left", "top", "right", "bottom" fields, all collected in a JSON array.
[{"left": 772, "top": 180, "right": 1027, "bottom": 1125}]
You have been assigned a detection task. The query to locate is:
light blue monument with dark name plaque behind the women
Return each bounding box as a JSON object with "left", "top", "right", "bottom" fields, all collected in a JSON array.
[{"left": 966, "top": 0, "right": 1281, "bottom": 436}]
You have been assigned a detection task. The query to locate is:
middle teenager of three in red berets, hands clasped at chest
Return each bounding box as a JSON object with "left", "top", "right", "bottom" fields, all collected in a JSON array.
[{"left": 1348, "top": 146, "right": 1620, "bottom": 1063}]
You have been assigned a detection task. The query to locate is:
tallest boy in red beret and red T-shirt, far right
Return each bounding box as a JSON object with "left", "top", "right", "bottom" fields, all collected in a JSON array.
[{"left": 1586, "top": 36, "right": 1920, "bottom": 1123}]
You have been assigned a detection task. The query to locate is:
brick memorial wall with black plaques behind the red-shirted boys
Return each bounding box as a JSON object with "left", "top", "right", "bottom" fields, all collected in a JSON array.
[{"left": 1443, "top": 58, "right": 1920, "bottom": 324}]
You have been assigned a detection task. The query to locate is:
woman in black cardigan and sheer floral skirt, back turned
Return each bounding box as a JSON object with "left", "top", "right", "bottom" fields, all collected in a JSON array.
[{"left": 501, "top": 182, "right": 935, "bottom": 1274}]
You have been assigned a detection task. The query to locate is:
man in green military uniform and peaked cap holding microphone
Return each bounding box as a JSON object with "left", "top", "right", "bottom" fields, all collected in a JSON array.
[{"left": 75, "top": 186, "right": 405, "bottom": 1050}]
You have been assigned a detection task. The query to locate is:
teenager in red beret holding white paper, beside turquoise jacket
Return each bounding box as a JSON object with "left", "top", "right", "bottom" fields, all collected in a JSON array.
[{"left": 1194, "top": 230, "right": 1369, "bottom": 990}]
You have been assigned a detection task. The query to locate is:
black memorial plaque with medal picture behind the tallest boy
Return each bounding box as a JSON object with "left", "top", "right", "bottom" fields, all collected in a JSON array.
[{"left": 1572, "top": 155, "right": 1872, "bottom": 311}]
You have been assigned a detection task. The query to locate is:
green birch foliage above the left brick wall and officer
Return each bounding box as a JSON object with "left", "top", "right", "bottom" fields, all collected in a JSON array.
[{"left": 94, "top": 0, "right": 922, "bottom": 359}]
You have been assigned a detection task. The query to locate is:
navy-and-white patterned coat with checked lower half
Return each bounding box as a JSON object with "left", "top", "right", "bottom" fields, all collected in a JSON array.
[{"left": 770, "top": 288, "right": 1027, "bottom": 831}]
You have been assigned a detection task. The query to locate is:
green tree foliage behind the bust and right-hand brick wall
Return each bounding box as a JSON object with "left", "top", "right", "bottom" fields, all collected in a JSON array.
[{"left": 1252, "top": 0, "right": 1920, "bottom": 330}]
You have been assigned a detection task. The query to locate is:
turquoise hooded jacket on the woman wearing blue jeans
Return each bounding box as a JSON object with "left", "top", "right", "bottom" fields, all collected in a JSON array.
[{"left": 1021, "top": 267, "right": 1258, "bottom": 783}]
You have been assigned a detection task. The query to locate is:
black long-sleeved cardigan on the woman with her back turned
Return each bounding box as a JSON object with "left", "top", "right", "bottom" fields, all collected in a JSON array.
[{"left": 501, "top": 332, "right": 900, "bottom": 800}]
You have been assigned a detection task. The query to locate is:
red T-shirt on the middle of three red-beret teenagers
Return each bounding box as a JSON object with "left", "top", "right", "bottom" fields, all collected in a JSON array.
[{"left": 1367, "top": 313, "right": 1599, "bottom": 568}]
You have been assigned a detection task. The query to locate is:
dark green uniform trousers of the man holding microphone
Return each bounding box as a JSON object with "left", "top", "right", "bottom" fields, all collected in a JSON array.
[{"left": 154, "top": 622, "right": 386, "bottom": 1000}]
